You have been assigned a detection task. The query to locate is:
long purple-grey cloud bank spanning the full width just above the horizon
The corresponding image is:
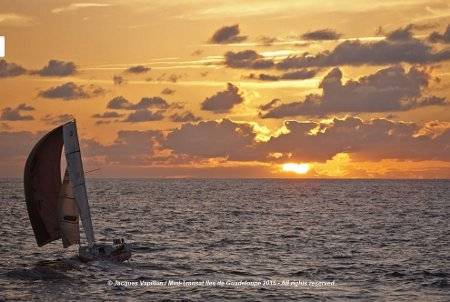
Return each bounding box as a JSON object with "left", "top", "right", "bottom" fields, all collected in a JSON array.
[{"left": 0, "top": 117, "right": 450, "bottom": 174}]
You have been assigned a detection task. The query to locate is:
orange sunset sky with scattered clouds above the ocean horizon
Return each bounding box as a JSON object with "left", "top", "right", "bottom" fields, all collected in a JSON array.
[{"left": 0, "top": 0, "right": 450, "bottom": 178}]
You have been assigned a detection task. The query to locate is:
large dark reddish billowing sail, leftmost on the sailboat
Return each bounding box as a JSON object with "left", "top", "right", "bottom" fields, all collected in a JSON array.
[{"left": 24, "top": 126, "right": 63, "bottom": 246}]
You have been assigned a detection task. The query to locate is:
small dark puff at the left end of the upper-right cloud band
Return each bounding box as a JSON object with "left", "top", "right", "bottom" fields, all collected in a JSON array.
[{"left": 225, "top": 50, "right": 275, "bottom": 69}]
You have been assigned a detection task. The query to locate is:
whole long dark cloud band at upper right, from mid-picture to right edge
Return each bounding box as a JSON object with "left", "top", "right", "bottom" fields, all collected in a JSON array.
[{"left": 224, "top": 37, "right": 450, "bottom": 70}]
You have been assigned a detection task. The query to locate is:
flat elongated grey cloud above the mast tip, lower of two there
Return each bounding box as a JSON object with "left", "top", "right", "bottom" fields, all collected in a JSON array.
[{"left": 38, "top": 82, "right": 105, "bottom": 101}]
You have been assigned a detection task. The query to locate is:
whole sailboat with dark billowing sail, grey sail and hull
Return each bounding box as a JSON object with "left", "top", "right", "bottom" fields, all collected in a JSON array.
[{"left": 24, "top": 120, "right": 131, "bottom": 262}]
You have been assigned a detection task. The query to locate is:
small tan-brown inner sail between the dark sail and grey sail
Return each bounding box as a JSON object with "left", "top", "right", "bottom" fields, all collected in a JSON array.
[{"left": 58, "top": 168, "right": 80, "bottom": 247}]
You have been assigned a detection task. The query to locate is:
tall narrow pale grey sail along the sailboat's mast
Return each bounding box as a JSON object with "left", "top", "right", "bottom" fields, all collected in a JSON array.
[{"left": 63, "top": 120, "right": 95, "bottom": 246}]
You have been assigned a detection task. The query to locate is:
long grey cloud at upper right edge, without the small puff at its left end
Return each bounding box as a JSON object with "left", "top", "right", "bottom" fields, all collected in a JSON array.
[{"left": 276, "top": 38, "right": 450, "bottom": 69}]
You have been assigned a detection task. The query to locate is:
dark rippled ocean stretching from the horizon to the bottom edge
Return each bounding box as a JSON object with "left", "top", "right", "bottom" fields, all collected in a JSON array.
[{"left": 0, "top": 178, "right": 450, "bottom": 301}]
